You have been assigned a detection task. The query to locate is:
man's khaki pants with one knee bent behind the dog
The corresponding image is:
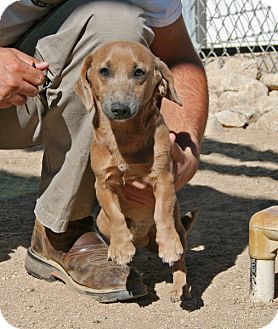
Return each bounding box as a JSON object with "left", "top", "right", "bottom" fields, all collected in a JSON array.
[{"left": 0, "top": 0, "right": 153, "bottom": 232}]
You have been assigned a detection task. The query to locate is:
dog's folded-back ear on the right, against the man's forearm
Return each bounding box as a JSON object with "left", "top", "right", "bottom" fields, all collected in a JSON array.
[{"left": 155, "top": 58, "right": 182, "bottom": 106}]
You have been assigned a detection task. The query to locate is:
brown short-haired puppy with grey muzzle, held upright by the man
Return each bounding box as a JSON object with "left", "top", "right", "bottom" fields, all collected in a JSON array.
[{"left": 76, "top": 41, "right": 194, "bottom": 301}]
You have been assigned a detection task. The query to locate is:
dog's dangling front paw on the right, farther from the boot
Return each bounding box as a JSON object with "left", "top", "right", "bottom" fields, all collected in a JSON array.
[{"left": 158, "top": 236, "right": 184, "bottom": 266}]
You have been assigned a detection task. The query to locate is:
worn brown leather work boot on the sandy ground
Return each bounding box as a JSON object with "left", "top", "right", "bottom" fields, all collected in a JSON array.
[{"left": 25, "top": 217, "right": 147, "bottom": 303}]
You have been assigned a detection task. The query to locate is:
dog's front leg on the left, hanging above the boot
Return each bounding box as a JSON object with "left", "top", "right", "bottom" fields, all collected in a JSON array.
[{"left": 96, "top": 178, "right": 136, "bottom": 266}]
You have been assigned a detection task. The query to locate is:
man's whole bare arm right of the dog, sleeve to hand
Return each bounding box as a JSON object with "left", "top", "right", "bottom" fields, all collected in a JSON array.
[{"left": 151, "top": 16, "right": 208, "bottom": 190}]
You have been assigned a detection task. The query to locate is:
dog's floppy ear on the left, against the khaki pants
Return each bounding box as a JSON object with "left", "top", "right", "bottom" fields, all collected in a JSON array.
[{"left": 75, "top": 55, "right": 94, "bottom": 111}]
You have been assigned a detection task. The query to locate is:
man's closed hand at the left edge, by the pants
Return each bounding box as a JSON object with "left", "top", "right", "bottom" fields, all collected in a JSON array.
[{"left": 0, "top": 48, "right": 48, "bottom": 109}]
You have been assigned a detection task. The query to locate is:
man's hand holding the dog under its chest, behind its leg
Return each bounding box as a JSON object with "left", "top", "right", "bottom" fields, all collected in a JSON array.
[{"left": 123, "top": 133, "right": 199, "bottom": 206}]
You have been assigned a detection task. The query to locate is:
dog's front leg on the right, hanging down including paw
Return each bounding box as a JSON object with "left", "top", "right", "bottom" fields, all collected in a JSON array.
[{"left": 154, "top": 172, "right": 184, "bottom": 265}]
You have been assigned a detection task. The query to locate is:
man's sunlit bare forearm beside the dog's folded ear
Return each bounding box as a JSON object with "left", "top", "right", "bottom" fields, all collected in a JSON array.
[{"left": 161, "top": 62, "right": 208, "bottom": 152}]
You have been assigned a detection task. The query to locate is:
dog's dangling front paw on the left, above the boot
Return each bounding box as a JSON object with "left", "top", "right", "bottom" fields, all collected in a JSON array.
[{"left": 108, "top": 242, "right": 136, "bottom": 267}]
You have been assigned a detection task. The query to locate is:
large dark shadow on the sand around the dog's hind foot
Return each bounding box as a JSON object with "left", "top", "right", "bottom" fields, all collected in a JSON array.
[{"left": 134, "top": 186, "right": 275, "bottom": 311}]
